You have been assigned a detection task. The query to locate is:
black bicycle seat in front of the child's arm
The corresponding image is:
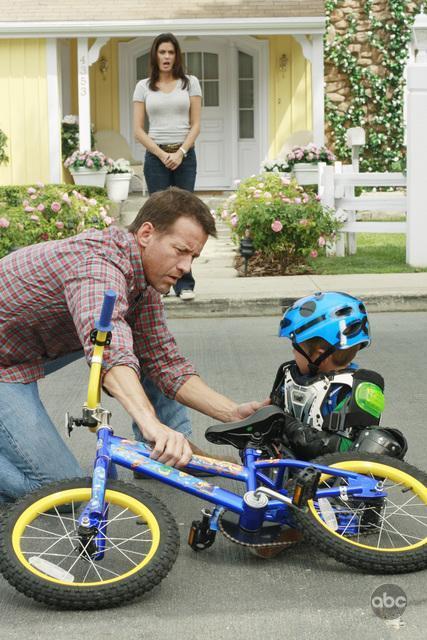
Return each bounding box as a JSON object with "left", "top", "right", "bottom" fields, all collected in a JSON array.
[{"left": 205, "top": 405, "right": 285, "bottom": 449}]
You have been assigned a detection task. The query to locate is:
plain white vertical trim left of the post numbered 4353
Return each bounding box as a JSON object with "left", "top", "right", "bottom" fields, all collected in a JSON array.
[{"left": 46, "top": 38, "right": 62, "bottom": 183}]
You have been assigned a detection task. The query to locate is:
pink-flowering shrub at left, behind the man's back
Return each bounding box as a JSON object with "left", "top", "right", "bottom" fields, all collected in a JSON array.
[{"left": 0, "top": 184, "right": 111, "bottom": 257}]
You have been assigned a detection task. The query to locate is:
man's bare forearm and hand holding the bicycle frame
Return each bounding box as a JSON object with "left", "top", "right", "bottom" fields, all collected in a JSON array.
[{"left": 103, "top": 366, "right": 192, "bottom": 467}]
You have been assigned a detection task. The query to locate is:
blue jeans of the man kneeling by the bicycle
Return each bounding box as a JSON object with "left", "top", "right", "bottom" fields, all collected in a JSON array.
[{"left": 0, "top": 379, "right": 191, "bottom": 503}]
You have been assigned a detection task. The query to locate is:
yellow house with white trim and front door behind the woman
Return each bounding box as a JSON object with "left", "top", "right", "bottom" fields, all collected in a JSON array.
[{"left": 0, "top": 0, "right": 325, "bottom": 189}]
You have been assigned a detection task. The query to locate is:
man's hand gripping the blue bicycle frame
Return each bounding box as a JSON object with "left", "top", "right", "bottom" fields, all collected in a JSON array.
[{"left": 139, "top": 420, "right": 193, "bottom": 467}]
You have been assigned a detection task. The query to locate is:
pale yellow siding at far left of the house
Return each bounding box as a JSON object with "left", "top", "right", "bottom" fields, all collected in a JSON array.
[{"left": 0, "top": 39, "right": 50, "bottom": 185}]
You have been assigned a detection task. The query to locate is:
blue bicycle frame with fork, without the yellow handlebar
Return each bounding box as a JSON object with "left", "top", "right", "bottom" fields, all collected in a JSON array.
[{"left": 79, "top": 427, "right": 385, "bottom": 559}]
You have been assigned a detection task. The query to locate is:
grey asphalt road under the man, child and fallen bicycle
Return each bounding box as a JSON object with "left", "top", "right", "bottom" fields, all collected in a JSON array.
[{"left": 0, "top": 313, "right": 427, "bottom": 640}]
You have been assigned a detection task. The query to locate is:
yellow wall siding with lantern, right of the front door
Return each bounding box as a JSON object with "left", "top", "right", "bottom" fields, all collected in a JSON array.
[{"left": 262, "top": 36, "right": 312, "bottom": 158}]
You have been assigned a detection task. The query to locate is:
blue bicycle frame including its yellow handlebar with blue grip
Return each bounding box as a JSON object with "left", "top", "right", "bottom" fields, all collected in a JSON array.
[{"left": 74, "top": 292, "right": 385, "bottom": 559}]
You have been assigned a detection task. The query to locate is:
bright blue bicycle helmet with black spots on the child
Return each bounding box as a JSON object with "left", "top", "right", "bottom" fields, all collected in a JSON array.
[{"left": 279, "top": 291, "right": 371, "bottom": 351}]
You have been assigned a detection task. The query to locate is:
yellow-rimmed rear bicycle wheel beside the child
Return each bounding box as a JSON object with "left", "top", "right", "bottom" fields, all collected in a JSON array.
[{"left": 296, "top": 452, "right": 427, "bottom": 573}]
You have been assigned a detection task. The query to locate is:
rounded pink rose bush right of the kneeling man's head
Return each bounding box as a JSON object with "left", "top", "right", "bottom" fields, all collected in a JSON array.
[{"left": 218, "top": 173, "right": 341, "bottom": 275}]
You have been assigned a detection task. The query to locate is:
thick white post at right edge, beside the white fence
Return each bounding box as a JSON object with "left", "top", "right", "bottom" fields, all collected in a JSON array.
[{"left": 406, "top": 58, "right": 427, "bottom": 267}]
